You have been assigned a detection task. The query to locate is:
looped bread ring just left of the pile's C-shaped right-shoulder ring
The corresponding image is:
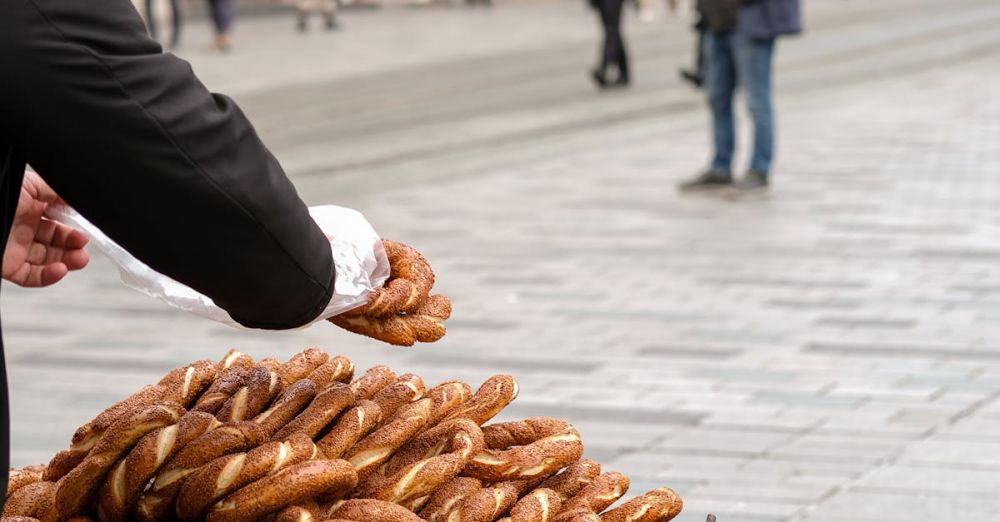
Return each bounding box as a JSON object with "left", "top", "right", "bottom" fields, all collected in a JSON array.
[{"left": 358, "top": 419, "right": 484, "bottom": 511}]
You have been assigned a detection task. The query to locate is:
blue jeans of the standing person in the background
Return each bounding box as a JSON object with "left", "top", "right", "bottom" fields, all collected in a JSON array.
[{"left": 704, "top": 32, "right": 774, "bottom": 175}]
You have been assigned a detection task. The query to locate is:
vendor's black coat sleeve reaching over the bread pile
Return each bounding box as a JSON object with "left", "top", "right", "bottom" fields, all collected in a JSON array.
[{"left": 0, "top": 0, "right": 334, "bottom": 329}]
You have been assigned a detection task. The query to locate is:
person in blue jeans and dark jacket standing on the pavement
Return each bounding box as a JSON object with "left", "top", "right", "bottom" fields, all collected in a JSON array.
[{"left": 679, "top": 0, "right": 802, "bottom": 192}]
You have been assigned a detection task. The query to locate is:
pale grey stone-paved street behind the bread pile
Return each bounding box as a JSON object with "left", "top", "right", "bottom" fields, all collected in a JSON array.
[{"left": 3, "top": 0, "right": 1000, "bottom": 522}]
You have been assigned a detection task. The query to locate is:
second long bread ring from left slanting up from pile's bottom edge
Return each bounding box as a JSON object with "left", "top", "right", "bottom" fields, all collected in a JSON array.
[{"left": 97, "top": 411, "right": 219, "bottom": 522}]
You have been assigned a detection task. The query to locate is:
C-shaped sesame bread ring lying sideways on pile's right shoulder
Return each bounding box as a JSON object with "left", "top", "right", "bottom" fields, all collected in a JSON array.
[{"left": 465, "top": 418, "right": 583, "bottom": 482}]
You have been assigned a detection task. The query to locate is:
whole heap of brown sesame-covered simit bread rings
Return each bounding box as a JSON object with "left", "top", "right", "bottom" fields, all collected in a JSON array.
[{"left": 2, "top": 348, "right": 681, "bottom": 522}]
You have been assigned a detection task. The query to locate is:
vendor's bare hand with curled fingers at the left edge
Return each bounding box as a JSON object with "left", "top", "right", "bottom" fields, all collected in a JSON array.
[{"left": 3, "top": 171, "right": 90, "bottom": 287}]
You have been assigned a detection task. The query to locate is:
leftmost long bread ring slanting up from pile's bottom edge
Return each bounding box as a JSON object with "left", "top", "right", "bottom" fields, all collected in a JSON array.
[{"left": 55, "top": 404, "right": 185, "bottom": 519}]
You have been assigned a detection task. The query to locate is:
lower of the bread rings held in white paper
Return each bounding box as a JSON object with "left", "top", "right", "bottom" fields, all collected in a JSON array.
[{"left": 328, "top": 295, "right": 451, "bottom": 346}]
